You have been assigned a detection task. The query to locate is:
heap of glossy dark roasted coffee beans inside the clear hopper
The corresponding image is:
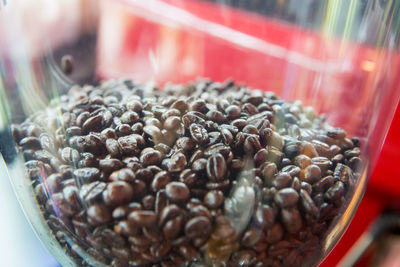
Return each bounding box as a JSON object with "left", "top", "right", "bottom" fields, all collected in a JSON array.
[{"left": 12, "top": 79, "right": 361, "bottom": 267}]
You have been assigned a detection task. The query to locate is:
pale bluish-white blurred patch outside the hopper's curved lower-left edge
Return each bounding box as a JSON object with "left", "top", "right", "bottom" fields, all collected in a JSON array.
[{"left": 0, "top": 155, "right": 59, "bottom": 267}]
